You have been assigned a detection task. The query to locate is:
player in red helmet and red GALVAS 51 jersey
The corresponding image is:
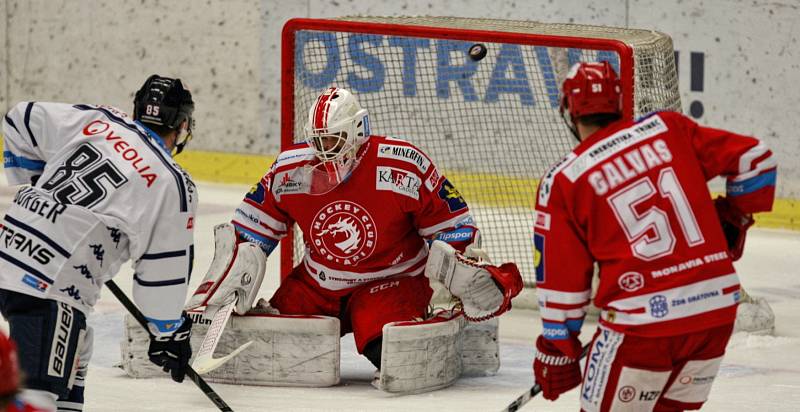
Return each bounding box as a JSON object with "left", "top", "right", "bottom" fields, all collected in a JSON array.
[{"left": 534, "top": 62, "right": 776, "bottom": 411}]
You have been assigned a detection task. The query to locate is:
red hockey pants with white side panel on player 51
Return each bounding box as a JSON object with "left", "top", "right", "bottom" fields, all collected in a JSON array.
[{"left": 580, "top": 324, "right": 733, "bottom": 412}]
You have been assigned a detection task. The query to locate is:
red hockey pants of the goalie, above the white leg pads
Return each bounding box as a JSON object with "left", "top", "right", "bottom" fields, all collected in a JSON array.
[{"left": 270, "top": 264, "right": 433, "bottom": 353}]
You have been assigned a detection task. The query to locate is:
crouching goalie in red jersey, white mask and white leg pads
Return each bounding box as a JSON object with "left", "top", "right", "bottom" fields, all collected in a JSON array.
[{"left": 117, "top": 88, "right": 522, "bottom": 393}]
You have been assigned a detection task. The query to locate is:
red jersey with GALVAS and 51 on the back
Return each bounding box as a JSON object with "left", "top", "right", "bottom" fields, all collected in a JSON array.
[{"left": 534, "top": 112, "right": 776, "bottom": 340}]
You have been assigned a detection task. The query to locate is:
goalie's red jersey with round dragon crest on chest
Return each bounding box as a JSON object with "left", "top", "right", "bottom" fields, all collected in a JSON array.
[{"left": 233, "top": 136, "right": 473, "bottom": 290}]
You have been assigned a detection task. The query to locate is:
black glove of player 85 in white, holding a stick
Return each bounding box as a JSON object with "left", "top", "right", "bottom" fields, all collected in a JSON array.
[{"left": 147, "top": 312, "right": 192, "bottom": 383}]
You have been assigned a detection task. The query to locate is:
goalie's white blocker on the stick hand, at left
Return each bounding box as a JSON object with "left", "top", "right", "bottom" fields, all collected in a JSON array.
[{"left": 186, "top": 223, "right": 267, "bottom": 315}]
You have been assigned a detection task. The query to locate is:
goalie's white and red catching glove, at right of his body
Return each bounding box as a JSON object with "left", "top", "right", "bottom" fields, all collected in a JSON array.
[{"left": 425, "top": 240, "right": 522, "bottom": 322}]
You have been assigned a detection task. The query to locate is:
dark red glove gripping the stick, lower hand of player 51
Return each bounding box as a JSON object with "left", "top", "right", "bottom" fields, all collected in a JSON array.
[{"left": 533, "top": 335, "right": 581, "bottom": 401}]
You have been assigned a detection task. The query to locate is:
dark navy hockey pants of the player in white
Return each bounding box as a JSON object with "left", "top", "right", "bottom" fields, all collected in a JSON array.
[{"left": 0, "top": 289, "right": 92, "bottom": 411}]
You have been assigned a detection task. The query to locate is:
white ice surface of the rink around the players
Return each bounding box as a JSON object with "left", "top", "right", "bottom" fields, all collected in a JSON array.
[{"left": 0, "top": 178, "right": 800, "bottom": 412}]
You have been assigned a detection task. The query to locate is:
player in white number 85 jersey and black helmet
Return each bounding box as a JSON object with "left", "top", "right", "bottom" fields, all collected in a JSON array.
[{"left": 0, "top": 75, "right": 197, "bottom": 411}]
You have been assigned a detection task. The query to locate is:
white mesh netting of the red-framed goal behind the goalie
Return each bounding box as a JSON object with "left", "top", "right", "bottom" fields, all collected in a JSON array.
[{"left": 284, "top": 17, "right": 680, "bottom": 284}]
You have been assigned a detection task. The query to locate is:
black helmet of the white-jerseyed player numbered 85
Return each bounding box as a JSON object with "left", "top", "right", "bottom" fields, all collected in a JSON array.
[{"left": 133, "top": 74, "right": 194, "bottom": 154}]
